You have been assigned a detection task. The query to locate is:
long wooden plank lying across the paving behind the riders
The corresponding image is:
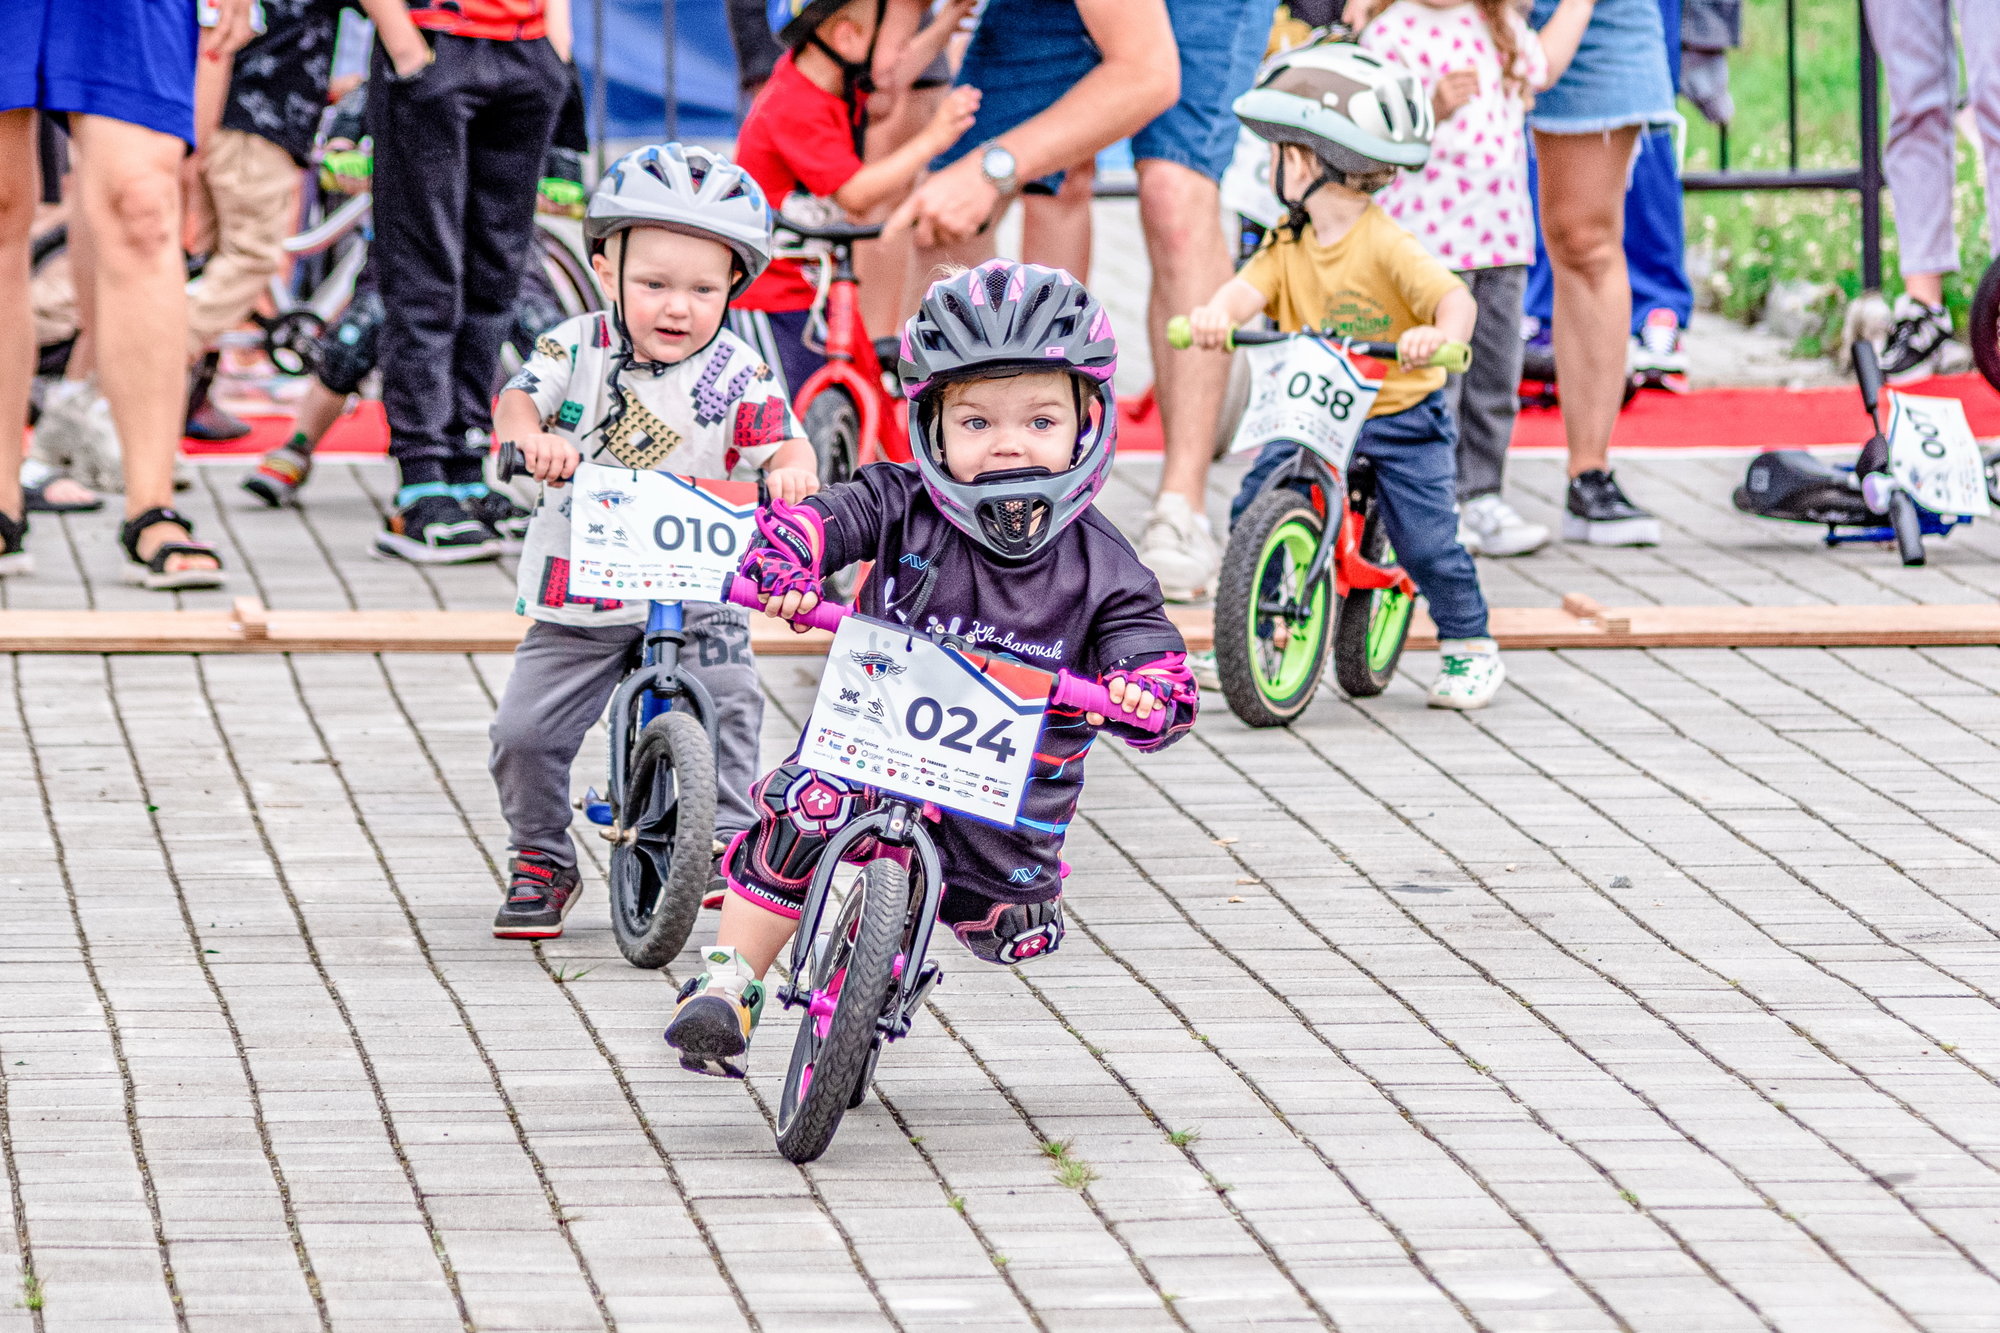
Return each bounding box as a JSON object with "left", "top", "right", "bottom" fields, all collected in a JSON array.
[{"left": 0, "top": 598, "right": 2000, "bottom": 656}]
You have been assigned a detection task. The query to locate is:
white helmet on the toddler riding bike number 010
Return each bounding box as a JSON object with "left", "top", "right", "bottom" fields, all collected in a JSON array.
[{"left": 584, "top": 144, "right": 770, "bottom": 300}]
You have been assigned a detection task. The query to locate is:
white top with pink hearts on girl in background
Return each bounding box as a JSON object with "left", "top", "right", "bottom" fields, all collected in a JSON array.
[{"left": 1362, "top": 0, "right": 1548, "bottom": 272}]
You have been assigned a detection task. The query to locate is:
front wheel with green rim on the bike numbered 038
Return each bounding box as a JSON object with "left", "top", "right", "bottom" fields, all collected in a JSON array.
[{"left": 1216, "top": 486, "right": 1334, "bottom": 727}]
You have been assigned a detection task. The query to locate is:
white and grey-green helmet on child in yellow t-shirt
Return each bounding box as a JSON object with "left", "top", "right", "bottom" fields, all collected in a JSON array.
[{"left": 1234, "top": 42, "right": 1434, "bottom": 174}]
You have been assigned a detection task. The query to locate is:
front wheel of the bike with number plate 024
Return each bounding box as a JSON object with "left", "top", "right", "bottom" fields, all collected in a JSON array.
[{"left": 778, "top": 859, "right": 910, "bottom": 1163}]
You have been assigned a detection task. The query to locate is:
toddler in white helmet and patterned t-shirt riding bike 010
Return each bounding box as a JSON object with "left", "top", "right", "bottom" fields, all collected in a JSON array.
[{"left": 490, "top": 144, "right": 820, "bottom": 939}]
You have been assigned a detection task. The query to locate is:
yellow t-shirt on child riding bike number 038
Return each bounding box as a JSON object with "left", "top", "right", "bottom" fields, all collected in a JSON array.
[{"left": 1236, "top": 204, "right": 1466, "bottom": 416}]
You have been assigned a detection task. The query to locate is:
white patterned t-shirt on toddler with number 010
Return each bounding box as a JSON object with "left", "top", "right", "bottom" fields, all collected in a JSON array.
[{"left": 506, "top": 312, "right": 806, "bottom": 624}]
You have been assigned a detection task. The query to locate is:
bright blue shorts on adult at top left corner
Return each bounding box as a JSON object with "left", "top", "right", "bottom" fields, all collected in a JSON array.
[{"left": 0, "top": 0, "right": 198, "bottom": 148}]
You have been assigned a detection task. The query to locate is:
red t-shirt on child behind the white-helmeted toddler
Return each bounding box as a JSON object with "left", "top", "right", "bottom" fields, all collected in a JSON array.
[{"left": 736, "top": 54, "right": 866, "bottom": 310}]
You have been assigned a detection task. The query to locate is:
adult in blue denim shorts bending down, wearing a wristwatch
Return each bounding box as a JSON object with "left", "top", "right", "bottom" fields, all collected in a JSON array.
[{"left": 890, "top": 0, "right": 1278, "bottom": 600}]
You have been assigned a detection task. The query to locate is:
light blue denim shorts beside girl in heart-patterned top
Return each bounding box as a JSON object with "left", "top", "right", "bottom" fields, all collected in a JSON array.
[{"left": 1528, "top": 0, "right": 1682, "bottom": 134}]
